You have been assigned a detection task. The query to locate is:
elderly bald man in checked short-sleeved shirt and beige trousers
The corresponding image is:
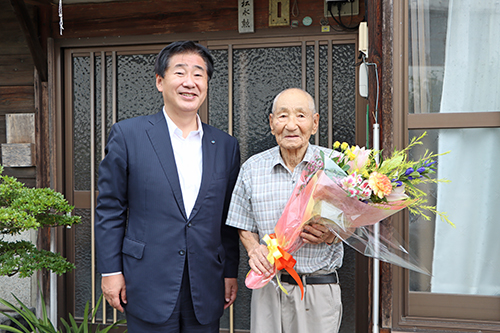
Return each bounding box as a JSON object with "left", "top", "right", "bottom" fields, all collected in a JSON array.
[{"left": 226, "top": 88, "right": 343, "bottom": 333}]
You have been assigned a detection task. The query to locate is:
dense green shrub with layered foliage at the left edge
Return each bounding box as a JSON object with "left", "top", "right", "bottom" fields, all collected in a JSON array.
[{"left": 0, "top": 166, "right": 80, "bottom": 277}]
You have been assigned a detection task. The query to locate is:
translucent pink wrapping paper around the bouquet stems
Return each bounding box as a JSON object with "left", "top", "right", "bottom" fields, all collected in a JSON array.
[{"left": 245, "top": 170, "right": 412, "bottom": 289}]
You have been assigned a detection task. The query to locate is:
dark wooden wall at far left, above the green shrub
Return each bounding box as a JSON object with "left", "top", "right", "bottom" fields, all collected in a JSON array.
[{"left": 0, "top": 0, "right": 36, "bottom": 186}]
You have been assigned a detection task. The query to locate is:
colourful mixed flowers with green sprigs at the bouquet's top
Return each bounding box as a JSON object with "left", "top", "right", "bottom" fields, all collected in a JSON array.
[{"left": 330, "top": 132, "right": 455, "bottom": 226}]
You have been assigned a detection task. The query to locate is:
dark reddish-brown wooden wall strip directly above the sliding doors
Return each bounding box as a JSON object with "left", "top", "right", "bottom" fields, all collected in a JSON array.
[{"left": 51, "top": 0, "right": 365, "bottom": 38}]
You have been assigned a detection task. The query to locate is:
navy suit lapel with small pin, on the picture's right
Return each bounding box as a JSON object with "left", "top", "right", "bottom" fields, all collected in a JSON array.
[{"left": 189, "top": 124, "right": 216, "bottom": 220}]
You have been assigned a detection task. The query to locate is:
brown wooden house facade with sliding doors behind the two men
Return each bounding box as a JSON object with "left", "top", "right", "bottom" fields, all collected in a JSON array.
[{"left": 0, "top": 0, "right": 500, "bottom": 332}]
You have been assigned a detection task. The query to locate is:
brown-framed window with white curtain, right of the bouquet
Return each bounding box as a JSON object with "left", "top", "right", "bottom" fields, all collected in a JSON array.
[{"left": 394, "top": 0, "right": 500, "bottom": 331}]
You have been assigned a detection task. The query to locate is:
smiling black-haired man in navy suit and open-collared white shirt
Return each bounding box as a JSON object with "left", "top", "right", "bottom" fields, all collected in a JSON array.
[{"left": 95, "top": 41, "right": 240, "bottom": 333}]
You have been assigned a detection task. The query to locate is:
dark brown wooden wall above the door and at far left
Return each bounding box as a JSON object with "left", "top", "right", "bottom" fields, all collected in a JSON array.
[{"left": 0, "top": 0, "right": 365, "bottom": 186}]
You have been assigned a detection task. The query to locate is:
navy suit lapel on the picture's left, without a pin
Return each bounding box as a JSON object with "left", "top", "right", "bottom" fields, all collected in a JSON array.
[{"left": 146, "top": 110, "right": 187, "bottom": 219}]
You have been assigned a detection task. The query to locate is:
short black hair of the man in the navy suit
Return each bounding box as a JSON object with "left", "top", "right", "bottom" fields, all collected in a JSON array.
[{"left": 155, "top": 41, "right": 214, "bottom": 81}]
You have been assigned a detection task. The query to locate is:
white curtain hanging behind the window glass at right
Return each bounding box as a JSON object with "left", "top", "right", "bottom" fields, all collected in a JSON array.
[{"left": 431, "top": 0, "right": 500, "bottom": 295}]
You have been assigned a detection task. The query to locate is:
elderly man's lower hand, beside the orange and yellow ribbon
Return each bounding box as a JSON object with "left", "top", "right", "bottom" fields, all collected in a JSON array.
[{"left": 239, "top": 230, "right": 274, "bottom": 277}]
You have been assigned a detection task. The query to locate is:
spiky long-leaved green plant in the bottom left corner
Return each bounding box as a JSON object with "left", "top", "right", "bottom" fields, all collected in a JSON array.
[{"left": 0, "top": 295, "right": 125, "bottom": 333}]
